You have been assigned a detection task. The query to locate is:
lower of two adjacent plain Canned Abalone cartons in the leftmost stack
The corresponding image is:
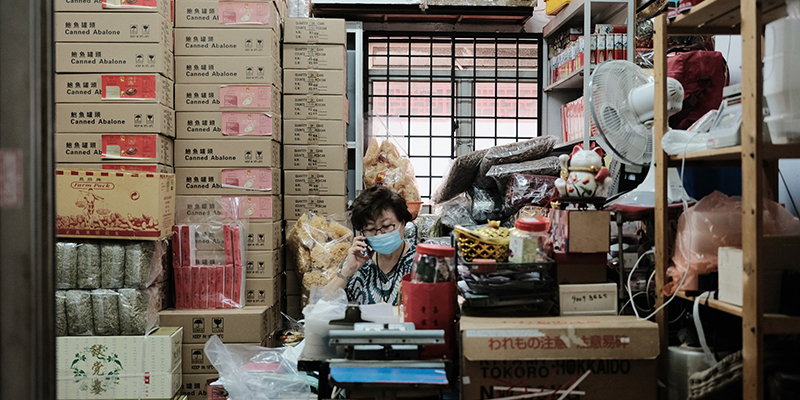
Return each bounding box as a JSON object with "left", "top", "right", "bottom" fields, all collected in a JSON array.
[{"left": 55, "top": 43, "right": 174, "bottom": 79}]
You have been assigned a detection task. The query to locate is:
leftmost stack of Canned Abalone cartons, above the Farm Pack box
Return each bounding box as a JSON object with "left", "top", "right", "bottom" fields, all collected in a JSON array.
[{"left": 54, "top": 0, "right": 175, "bottom": 172}]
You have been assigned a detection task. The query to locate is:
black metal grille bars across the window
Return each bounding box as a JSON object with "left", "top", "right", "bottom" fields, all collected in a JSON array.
[{"left": 363, "top": 31, "right": 543, "bottom": 199}]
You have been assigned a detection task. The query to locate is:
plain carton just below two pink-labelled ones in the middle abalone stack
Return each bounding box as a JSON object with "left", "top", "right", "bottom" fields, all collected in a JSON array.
[{"left": 175, "top": 139, "right": 281, "bottom": 168}]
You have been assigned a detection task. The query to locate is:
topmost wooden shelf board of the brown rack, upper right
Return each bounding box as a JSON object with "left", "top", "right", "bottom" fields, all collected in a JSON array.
[{"left": 667, "top": 0, "right": 786, "bottom": 35}]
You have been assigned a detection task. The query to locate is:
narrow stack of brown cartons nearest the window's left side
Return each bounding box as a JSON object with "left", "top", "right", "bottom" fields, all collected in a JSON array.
[{"left": 283, "top": 18, "right": 349, "bottom": 318}]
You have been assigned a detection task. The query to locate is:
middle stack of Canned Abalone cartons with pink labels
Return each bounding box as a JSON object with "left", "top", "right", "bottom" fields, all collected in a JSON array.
[{"left": 175, "top": 0, "right": 283, "bottom": 316}]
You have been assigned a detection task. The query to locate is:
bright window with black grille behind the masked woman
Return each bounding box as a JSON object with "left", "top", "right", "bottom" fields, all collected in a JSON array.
[{"left": 365, "top": 32, "right": 540, "bottom": 201}]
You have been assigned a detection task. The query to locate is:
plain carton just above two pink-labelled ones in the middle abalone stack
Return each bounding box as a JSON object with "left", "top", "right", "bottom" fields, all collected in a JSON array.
[{"left": 175, "top": 56, "right": 283, "bottom": 89}]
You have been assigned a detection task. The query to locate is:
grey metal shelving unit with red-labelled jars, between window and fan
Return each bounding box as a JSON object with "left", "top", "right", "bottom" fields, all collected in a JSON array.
[{"left": 540, "top": 0, "right": 636, "bottom": 147}]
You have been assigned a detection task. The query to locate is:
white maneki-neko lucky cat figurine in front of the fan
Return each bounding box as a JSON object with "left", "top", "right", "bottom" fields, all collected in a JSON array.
[{"left": 555, "top": 146, "right": 613, "bottom": 198}]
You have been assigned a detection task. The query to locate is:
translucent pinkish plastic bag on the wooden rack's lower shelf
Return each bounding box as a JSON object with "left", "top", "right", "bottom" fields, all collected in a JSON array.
[{"left": 663, "top": 191, "right": 800, "bottom": 296}]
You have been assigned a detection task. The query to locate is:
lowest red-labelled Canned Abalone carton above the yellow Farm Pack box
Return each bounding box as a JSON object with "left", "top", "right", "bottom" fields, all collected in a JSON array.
[{"left": 56, "top": 133, "right": 173, "bottom": 166}]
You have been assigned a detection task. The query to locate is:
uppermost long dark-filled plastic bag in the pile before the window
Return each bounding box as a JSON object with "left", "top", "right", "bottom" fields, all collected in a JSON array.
[{"left": 476, "top": 136, "right": 556, "bottom": 189}]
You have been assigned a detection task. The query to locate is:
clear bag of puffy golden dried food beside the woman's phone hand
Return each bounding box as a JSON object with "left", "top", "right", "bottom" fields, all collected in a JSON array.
[{"left": 286, "top": 212, "right": 353, "bottom": 304}]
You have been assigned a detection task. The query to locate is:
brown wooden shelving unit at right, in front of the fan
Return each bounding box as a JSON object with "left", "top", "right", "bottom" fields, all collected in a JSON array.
[{"left": 654, "top": 0, "right": 800, "bottom": 399}]
